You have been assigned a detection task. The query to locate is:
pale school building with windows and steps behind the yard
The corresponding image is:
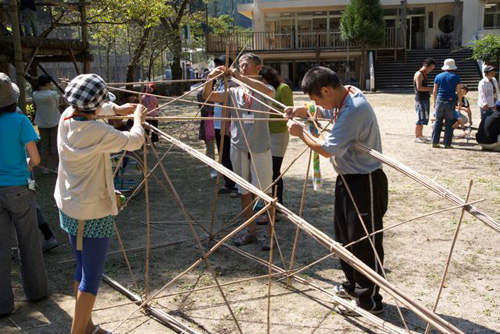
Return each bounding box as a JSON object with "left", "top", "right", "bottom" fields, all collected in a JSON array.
[{"left": 207, "top": 0, "right": 500, "bottom": 87}]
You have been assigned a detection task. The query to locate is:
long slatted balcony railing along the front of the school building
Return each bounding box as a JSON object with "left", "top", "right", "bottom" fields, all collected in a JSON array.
[{"left": 207, "top": 28, "right": 404, "bottom": 53}]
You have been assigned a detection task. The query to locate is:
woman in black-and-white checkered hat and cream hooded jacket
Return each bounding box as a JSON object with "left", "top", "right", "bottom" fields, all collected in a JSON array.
[{"left": 54, "top": 74, "right": 147, "bottom": 334}]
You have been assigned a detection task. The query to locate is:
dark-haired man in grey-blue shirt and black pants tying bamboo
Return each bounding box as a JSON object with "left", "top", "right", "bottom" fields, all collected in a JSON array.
[{"left": 285, "top": 66, "right": 388, "bottom": 316}]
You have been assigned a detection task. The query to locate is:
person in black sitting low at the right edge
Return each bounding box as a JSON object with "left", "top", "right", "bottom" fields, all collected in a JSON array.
[{"left": 476, "top": 101, "right": 500, "bottom": 152}]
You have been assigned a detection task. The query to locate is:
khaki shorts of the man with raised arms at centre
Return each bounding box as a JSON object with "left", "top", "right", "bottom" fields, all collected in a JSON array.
[{"left": 231, "top": 146, "right": 273, "bottom": 195}]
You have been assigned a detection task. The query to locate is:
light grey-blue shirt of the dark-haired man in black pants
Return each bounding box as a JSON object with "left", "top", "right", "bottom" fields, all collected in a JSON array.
[{"left": 319, "top": 87, "right": 382, "bottom": 174}]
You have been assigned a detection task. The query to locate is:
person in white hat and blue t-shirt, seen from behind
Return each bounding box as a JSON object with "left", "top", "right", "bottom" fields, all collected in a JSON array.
[{"left": 432, "top": 59, "right": 462, "bottom": 148}]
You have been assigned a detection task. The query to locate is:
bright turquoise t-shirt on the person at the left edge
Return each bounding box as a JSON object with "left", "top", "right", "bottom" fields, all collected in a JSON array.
[{"left": 0, "top": 112, "right": 38, "bottom": 186}]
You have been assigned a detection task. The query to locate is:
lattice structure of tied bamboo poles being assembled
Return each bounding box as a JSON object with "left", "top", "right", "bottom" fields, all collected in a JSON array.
[{"left": 62, "top": 61, "right": 500, "bottom": 333}]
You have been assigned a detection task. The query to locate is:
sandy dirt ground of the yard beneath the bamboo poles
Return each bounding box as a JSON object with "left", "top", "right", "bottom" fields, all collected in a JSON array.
[{"left": 0, "top": 92, "right": 500, "bottom": 333}]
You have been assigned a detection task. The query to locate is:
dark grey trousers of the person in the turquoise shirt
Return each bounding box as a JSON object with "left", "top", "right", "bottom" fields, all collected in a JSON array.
[{"left": 0, "top": 186, "right": 47, "bottom": 314}]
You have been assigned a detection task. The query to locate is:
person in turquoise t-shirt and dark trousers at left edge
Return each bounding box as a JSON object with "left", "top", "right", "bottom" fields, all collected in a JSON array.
[{"left": 0, "top": 73, "right": 47, "bottom": 315}]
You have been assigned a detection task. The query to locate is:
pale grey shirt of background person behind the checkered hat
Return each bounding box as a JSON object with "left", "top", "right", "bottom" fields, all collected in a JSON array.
[{"left": 33, "top": 90, "right": 61, "bottom": 128}]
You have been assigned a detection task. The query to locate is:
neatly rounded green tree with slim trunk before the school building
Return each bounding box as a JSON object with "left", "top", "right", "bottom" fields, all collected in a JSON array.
[{"left": 340, "top": 0, "right": 385, "bottom": 89}]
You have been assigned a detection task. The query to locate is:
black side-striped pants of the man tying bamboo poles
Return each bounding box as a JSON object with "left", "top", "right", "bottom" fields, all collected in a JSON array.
[{"left": 334, "top": 169, "right": 388, "bottom": 310}]
